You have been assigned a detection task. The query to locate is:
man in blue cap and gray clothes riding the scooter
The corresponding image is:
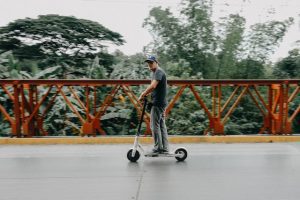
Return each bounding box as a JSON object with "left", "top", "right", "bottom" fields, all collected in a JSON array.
[{"left": 139, "top": 56, "right": 169, "bottom": 154}]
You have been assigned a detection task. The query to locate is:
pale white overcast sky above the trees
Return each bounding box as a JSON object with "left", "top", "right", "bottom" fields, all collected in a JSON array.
[{"left": 0, "top": 0, "right": 300, "bottom": 61}]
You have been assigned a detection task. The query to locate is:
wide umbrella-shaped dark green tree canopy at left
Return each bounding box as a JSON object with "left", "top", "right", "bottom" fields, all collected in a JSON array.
[{"left": 0, "top": 15, "right": 125, "bottom": 68}]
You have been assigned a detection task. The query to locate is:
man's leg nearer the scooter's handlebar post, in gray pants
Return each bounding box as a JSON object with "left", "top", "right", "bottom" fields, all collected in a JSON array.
[{"left": 150, "top": 106, "right": 163, "bottom": 150}]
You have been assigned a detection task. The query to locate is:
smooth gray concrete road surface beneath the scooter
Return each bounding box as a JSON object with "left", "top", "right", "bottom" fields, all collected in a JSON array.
[{"left": 0, "top": 143, "right": 300, "bottom": 200}]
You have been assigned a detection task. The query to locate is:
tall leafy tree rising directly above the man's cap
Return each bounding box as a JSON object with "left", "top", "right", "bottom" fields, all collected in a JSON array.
[{"left": 143, "top": 0, "right": 216, "bottom": 77}]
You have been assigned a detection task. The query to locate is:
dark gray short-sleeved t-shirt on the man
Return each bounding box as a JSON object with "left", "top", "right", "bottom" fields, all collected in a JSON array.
[{"left": 151, "top": 67, "right": 167, "bottom": 107}]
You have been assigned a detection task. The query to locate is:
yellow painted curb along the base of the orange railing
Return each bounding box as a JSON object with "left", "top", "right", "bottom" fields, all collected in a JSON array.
[{"left": 0, "top": 135, "right": 300, "bottom": 145}]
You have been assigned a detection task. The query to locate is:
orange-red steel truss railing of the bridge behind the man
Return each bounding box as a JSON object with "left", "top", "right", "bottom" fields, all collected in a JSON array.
[{"left": 0, "top": 79, "right": 300, "bottom": 137}]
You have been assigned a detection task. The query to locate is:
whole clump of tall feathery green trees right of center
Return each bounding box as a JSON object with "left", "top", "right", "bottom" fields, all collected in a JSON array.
[{"left": 143, "top": 0, "right": 293, "bottom": 78}]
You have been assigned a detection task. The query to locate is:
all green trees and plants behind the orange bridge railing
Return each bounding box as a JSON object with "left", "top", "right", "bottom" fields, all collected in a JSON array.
[{"left": 0, "top": 3, "right": 300, "bottom": 136}]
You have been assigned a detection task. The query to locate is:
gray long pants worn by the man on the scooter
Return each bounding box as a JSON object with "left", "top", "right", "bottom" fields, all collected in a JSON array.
[{"left": 150, "top": 106, "right": 169, "bottom": 151}]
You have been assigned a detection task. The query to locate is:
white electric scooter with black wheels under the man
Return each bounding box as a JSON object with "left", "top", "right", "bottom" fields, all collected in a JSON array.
[{"left": 127, "top": 98, "right": 188, "bottom": 162}]
